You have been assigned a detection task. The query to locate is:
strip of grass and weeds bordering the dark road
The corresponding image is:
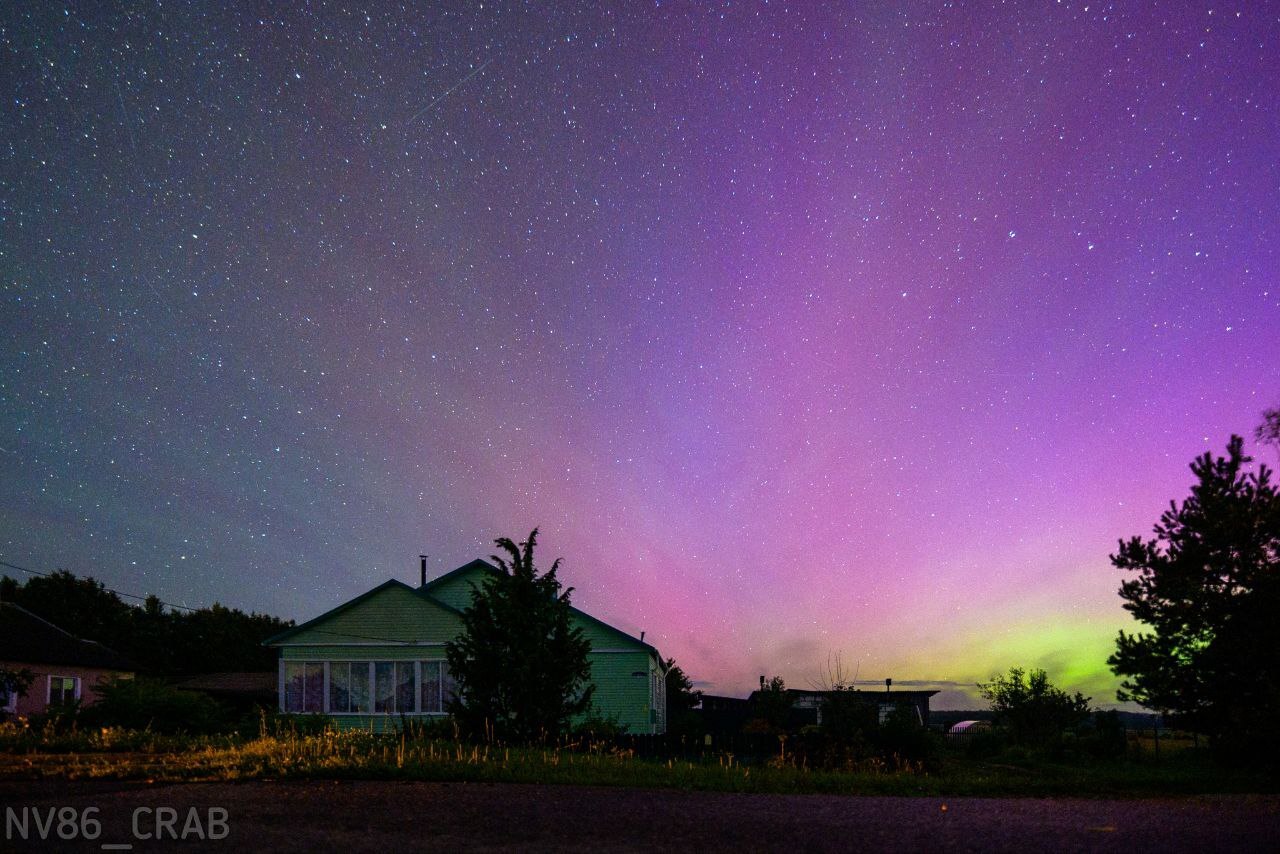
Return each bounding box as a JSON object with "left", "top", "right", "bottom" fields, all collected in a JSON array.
[{"left": 0, "top": 730, "right": 1280, "bottom": 798}]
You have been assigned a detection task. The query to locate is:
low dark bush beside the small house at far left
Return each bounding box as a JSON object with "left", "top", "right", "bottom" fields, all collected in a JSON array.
[{"left": 81, "top": 679, "right": 230, "bottom": 735}]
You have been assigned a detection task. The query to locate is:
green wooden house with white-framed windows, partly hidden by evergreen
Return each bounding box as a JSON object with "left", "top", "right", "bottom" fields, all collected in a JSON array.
[{"left": 265, "top": 561, "right": 667, "bottom": 734}]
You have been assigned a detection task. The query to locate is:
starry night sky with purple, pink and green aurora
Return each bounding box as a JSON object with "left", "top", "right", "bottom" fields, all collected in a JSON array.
[{"left": 0, "top": 0, "right": 1280, "bottom": 707}]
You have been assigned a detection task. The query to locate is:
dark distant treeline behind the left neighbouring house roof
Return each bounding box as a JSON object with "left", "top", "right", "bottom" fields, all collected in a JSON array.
[{"left": 0, "top": 571, "right": 293, "bottom": 679}]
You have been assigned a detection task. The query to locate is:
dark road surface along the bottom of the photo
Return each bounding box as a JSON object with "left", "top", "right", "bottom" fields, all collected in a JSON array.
[{"left": 0, "top": 781, "right": 1280, "bottom": 851}]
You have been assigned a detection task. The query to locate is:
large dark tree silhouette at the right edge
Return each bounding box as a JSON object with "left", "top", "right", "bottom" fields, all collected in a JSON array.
[{"left": 1107, "top": 435, "right": 1280, "bottom": 762}]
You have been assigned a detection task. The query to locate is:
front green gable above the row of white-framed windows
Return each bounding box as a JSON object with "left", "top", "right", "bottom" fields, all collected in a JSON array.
[{"left": 265, "top": 580, "right": 462, "bottom": 647}]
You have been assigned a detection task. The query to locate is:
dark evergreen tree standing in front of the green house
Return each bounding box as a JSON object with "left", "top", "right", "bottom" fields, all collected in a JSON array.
[{"left": 444, "top": 528, "right": 595, "bottom": 743}]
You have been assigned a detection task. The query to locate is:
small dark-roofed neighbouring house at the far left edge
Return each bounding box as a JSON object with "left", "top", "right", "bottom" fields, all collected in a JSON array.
[{"left": 0, "top": 602, "right": 136, "bottom": 716}]
